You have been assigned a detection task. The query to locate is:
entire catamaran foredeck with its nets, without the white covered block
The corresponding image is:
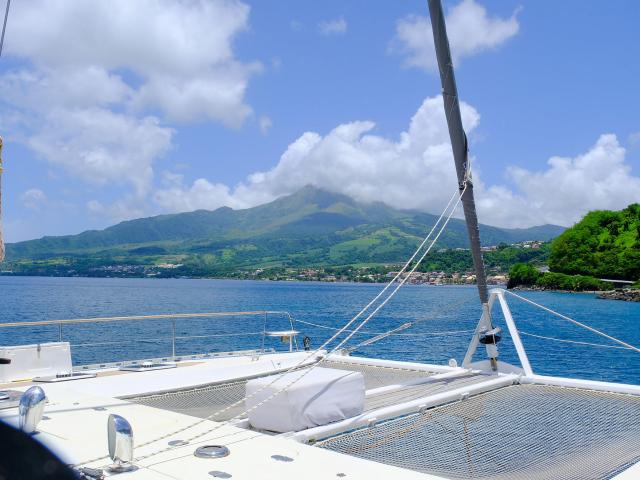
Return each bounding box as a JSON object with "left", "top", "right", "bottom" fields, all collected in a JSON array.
[{"left": 0, "top": 352, "right": 640, "bottom": 479}]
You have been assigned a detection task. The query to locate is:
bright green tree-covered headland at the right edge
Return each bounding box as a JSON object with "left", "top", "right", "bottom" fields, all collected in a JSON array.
[{"left": 549, "top": 203, "right": 640, "bottom": 280}]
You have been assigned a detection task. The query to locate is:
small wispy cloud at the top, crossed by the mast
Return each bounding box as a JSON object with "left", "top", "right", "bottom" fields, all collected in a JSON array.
[{"left": 392, "top": 0, "right": 520, "bottom": 71}]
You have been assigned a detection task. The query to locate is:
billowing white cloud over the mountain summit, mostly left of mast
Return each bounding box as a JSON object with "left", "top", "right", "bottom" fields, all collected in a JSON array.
[{"left": 156, "top": 97, "right": 480, "bottom": 215}]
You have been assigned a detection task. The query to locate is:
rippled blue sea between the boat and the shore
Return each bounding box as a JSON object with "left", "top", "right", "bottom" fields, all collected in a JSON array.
[{"left": 0, "top": 276, "right": 640, "bottom": 384}]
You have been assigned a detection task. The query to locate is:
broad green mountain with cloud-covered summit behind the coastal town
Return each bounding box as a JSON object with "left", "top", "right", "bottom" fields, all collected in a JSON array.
[{"left": 7, "top": 186, "right": 564, "bottom": 270}]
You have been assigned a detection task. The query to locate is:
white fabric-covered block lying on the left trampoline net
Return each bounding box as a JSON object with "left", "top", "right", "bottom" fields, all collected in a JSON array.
[{"left": 245, "top": 367, "right": 365, "bottom": 432}]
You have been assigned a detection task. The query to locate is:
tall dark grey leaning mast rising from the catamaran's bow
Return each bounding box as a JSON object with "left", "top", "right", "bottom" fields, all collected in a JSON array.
[{"left": 429, "top": 0, "right": 499, "bottom": 369}]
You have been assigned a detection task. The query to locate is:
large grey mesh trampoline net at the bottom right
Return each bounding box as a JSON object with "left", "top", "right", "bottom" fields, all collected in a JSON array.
[{"left": 316, "top": 385, "right": 640, "bottom": 480}]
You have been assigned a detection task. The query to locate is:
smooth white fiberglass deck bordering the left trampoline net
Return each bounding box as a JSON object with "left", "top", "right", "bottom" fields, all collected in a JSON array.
[{"left": 0, "top": 353, "right": 437, "bottom": 480}]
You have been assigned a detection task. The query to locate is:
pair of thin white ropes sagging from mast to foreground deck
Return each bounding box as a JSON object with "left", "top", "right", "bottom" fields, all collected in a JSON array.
[{"left": 76, "top": 184, "right": 466, "bottom": 466}]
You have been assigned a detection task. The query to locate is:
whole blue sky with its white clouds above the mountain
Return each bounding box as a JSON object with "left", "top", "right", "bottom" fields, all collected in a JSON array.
[{"left": 0, "top": 0, "right": 640, "bottom": 241}]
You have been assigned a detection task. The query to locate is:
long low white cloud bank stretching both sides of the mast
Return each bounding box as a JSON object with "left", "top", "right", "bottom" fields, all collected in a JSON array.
[{"left": 154, "top": 97, "right": 640, "bottom": 227}]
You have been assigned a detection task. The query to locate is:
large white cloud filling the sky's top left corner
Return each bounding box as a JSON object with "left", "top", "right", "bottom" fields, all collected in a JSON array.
[{"left": 6, "top": 0, "right": 261, "bottom": 127}]
